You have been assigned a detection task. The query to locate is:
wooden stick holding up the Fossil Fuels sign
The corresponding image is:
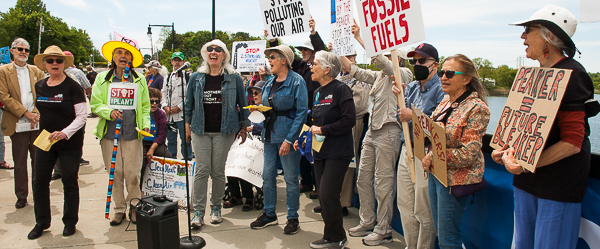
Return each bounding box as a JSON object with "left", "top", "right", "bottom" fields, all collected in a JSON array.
[{"left": 391, "top": 49, "right": 415, "bottom": 183}]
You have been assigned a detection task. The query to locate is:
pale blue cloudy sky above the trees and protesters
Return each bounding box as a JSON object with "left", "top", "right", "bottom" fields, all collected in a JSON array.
[{"left": 0, "top": 0, "right": 600, "bottom": 72}]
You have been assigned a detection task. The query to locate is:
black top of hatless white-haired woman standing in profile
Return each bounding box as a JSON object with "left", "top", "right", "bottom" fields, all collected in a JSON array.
[{"left": 312, "top": 80, "right": 356, "bottom": 160}]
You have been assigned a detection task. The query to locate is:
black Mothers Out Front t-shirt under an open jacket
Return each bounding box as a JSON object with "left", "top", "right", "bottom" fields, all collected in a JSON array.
[{"left": 203, "top": 74, "right": 224, "bottom": 132}]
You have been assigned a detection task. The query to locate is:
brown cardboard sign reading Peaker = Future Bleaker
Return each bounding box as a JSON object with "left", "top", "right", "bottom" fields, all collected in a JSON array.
[{"left": 490, "top": 67, "right": 571, "bottom": 172}]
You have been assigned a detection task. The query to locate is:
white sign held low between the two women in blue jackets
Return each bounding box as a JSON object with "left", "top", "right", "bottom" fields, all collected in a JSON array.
[{"left": 225, "top": 134, "right": 265, "bottom": 188}]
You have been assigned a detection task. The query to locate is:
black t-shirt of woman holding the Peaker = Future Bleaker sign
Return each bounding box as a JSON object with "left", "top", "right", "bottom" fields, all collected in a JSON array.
[{"left": 513, "top": 58, "right": 594, "bottom": 203}]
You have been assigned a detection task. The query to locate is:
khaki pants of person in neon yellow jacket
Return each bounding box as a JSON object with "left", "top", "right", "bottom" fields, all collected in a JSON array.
[{"left": 100, "top": 139, "right": 143, "bottom": 213}]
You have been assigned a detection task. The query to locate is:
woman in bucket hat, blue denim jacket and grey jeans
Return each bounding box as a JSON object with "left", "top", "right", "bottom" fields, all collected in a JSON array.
[{"left": 250, "top": 45, "right": 308, "bottom": 234}]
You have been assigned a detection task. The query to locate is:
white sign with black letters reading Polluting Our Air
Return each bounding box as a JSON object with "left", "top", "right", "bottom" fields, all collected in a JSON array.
[{"left": 258, "top": 0, "right": 310, "bottom": 39}]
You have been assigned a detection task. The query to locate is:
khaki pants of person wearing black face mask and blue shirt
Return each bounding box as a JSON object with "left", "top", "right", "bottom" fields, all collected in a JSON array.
[{"left": 397, "top": 146, "right": 435, "bottom": 249}]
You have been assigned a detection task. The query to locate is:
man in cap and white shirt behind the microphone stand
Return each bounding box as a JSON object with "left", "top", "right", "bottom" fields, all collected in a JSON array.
[{"left": 161, "top": 52, "right": 192, "bottom": 160}]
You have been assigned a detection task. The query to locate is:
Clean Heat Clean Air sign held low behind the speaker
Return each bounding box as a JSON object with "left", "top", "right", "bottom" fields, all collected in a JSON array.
[{"left": 142, "top": 157, "right": 196, "bottom": 211}]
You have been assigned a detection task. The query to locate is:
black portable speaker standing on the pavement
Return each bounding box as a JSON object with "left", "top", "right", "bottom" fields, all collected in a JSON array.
[{"left": 135, "top": 196, "right": 179, "bottom": 249}]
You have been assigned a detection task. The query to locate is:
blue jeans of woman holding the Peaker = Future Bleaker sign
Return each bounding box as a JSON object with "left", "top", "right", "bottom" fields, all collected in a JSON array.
[{"left": 513, "top": 187, "right": 581, "bottom": 249}]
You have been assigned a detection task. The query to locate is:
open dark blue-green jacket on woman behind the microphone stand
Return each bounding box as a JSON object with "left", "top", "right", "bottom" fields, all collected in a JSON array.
[{"left": 185, "top": 71, "right": 250, "bottom": 135}]
